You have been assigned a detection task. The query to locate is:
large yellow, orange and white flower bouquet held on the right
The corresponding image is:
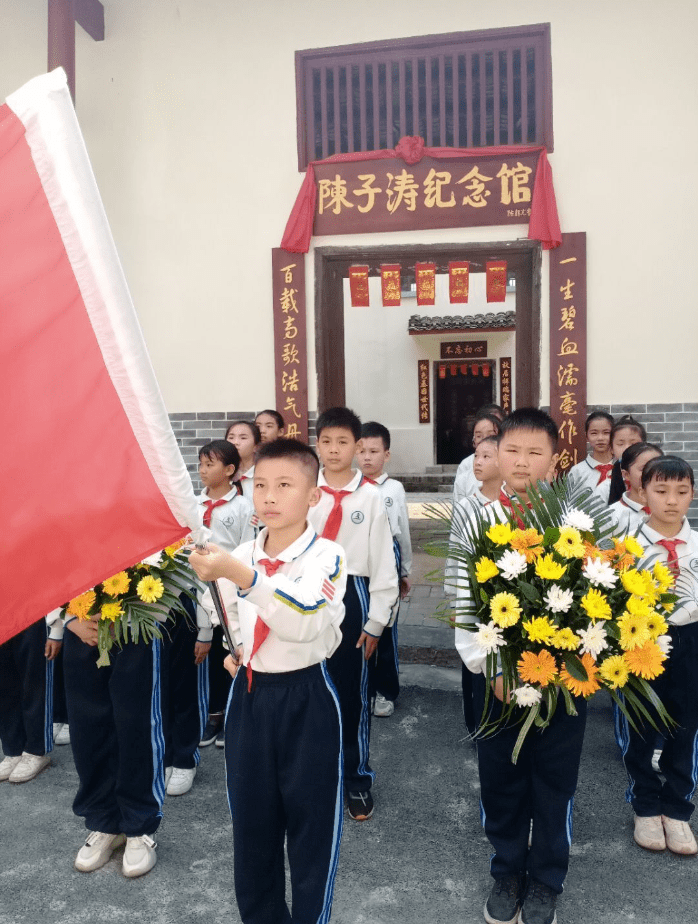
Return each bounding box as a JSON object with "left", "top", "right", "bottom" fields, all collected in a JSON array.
[{"left": 443, "top": 479, "right": 676, "bottom": 763}]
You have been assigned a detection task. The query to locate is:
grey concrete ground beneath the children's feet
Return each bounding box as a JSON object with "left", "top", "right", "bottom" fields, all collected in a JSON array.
[{"left": 0, "top": 497, "right": 698, "bottom": 924}]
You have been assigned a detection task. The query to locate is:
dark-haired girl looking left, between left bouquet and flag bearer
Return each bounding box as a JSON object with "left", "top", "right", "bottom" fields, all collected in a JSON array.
[{"left": 196, "top": 440, "right": 254, "bottom": 752}]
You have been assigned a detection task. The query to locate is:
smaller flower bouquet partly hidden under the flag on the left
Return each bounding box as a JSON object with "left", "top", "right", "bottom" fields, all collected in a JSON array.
[{"left": 61, "top": 539, "right": 197, "bottom": 667}]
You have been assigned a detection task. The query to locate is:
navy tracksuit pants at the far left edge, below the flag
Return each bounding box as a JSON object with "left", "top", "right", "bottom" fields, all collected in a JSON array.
[{"left": 0, "top": 619, "right": 53, "bottom": 757}]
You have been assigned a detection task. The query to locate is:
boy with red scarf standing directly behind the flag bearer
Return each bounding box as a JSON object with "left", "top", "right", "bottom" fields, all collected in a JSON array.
[{"left": 310, "top": 407, "right": 398, "bottom": 821}]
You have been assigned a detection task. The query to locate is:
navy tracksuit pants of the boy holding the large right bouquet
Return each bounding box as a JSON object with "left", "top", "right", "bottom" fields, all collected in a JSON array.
[{"left": 474, "top": 683, "right": 587, "bottom": 894}]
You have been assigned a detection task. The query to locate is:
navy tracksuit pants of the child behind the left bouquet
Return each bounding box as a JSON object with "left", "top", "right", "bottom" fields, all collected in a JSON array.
[{"left": 63, "top": 627, "right": 165, "bottom": 837}]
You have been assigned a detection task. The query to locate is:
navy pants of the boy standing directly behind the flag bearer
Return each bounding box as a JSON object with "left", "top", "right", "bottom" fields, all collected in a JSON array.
[{"left": 327, "top": 574, "right": 375, "bottom": 792}]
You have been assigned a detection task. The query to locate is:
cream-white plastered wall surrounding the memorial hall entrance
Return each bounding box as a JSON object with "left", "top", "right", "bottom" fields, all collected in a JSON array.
[{"left": 0, "top": 0, "right": 698, "bottom": 411}]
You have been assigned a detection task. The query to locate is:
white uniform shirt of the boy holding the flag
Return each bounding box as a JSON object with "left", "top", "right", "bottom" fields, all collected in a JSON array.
[{"left": 203, "top": 524, "right": 347, "bottom": 674}]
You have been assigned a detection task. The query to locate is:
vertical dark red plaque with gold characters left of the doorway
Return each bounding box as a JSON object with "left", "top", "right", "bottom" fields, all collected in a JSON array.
[{"left": 271, "top": 247, "right": 308, "bottom": 443}]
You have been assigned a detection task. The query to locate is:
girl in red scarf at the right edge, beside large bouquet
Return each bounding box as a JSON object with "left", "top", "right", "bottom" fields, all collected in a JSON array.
[{"left": 619, "top": 456, "right": 698, "bottom": 855}]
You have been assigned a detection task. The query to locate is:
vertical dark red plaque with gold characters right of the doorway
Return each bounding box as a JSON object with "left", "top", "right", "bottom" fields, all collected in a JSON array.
[{"left": 550, "top": 231, "right": 587, "bottom": 472}]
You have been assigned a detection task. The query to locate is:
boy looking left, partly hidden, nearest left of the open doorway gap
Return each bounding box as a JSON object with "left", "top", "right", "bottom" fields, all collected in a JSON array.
[{"left": 356, "top": 420, "right": 412, "bottom": 718}]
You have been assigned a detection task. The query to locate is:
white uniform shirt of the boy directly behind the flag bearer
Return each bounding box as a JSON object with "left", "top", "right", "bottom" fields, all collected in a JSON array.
[{"left": 308, "top": 472, "right": 398, "bottom": 636}]
